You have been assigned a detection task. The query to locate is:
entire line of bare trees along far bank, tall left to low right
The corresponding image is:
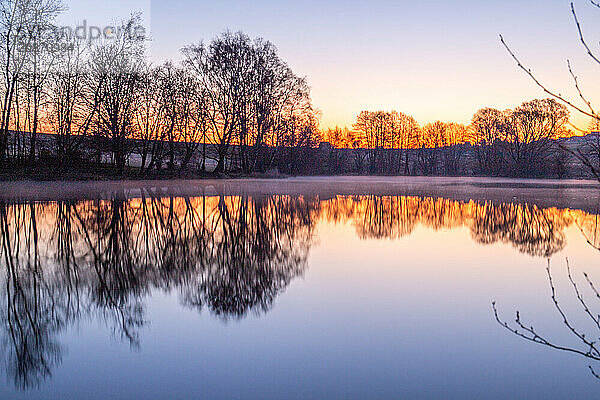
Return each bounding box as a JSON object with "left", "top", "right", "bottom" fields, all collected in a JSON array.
[{"left": 0, "top": 0, "right": 600, "bottom": 177}]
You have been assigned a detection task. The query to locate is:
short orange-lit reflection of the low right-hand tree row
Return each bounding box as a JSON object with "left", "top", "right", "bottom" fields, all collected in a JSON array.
[{"left": 321, "top": 196, "right": 572, "bottom": 257}]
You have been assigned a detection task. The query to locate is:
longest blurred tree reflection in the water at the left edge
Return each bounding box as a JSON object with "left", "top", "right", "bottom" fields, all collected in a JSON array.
[{"left": 0, "top": 204, "right": 70, "bottom": 387}]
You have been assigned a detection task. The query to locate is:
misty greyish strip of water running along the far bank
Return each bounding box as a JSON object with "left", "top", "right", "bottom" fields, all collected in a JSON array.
[{"left": 0, "top": 176, "right": 600, "bottom": 213}]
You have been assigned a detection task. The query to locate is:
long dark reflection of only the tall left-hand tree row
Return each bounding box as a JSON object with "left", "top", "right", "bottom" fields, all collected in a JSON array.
[{"left": 0, "top": 197, "right": 317, "bottom": 387}]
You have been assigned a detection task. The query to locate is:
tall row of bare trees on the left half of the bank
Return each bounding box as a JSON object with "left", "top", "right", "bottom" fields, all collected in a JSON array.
[{"left": 0, "top": 0, "right": 318, "bottom": 173}]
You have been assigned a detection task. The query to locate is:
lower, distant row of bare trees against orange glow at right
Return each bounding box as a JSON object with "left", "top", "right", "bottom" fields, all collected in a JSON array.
[{"left": 326, "top": 99, "right": 569, "bottom": 176}]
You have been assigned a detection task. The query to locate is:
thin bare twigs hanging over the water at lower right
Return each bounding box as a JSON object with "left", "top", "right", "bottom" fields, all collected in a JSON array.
[{"left": 492, "top": 261, "right": 600, "bottom": 379}]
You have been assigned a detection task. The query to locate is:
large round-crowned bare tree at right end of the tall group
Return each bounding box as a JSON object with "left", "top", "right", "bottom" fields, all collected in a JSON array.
[{"left": 183, "top": 32, "right": 312, "bottom": 173}]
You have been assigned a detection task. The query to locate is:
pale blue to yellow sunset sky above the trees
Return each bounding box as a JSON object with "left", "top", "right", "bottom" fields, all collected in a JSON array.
[{"left": 64, "top": 0, "right": 600, "bottom": 128}]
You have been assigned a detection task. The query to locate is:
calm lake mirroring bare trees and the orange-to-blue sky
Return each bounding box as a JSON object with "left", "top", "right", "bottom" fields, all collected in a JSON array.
[{"left": 0, "top": 178, "right": 600, "bottom": 399}]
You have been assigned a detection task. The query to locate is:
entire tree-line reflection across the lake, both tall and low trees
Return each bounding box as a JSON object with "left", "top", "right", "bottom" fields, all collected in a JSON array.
[{"left": 0, "top": 196, "right": 598, "bottom": 388}]
